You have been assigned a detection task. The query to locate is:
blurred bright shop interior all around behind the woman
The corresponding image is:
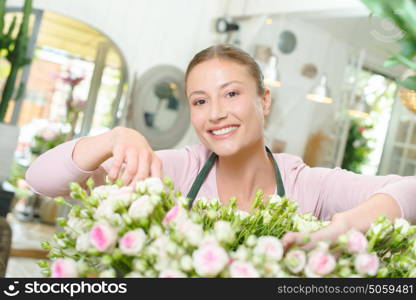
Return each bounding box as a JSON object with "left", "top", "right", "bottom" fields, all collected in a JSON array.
[{"left": 0, "top": 0, "right": 416, "bottom": 277}]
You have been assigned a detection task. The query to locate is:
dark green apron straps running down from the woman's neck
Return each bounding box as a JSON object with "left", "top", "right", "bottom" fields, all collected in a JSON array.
[{"left": 186, "top": 146, "right": 285, "bottom": 208}]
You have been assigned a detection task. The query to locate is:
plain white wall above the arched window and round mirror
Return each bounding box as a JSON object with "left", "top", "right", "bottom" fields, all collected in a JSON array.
[{"left": 7, "top": 0, "right": 226, "bottom": 147}]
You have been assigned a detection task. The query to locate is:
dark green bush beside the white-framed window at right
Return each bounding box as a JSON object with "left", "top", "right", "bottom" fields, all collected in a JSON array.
[{"left": 342, "top": 119, "right": 373, "bottom": 173}]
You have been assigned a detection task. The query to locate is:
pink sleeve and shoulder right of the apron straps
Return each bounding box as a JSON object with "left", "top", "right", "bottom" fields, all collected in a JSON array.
[{"left": 281, "top": 154, "right": 416, "bottom": 222}]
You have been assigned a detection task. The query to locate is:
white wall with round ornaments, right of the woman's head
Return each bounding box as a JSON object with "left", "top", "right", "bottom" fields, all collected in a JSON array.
[{"left": 236, "top": 16, "right": 348, "bottom": 156}]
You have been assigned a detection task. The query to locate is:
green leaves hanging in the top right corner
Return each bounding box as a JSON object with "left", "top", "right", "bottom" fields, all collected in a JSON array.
[{"left": 361, "top": 0, "right": 416, "bottom": 90}]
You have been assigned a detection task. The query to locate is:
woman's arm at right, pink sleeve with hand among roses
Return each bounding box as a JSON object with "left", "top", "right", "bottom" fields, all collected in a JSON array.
[{"left": 282, "top": 154, "right": 416, "bottom": 250}]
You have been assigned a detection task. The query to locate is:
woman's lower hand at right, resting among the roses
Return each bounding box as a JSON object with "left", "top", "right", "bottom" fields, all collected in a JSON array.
[{"left": 282, "top": 214, "right": 351, "bottom": 251}]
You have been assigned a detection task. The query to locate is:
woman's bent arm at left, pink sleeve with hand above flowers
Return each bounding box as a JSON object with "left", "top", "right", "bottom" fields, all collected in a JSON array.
[{"left": 26, "top": 127, "right": 162, "bottom": 197}]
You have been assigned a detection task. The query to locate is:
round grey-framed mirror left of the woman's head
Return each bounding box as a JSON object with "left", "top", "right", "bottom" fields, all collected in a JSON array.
[{"left": 127, "top": 65, "right": 190, "bottom": 150}]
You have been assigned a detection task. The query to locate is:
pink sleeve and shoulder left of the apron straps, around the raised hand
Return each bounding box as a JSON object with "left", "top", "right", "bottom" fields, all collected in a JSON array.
[{"left": 25, "top": 139, "right": 200, "bottom": 197}]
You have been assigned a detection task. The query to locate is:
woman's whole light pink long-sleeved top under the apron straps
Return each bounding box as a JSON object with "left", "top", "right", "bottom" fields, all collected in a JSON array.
[{"left": 26, "top": 140, "right": 416, "bottom": 221}]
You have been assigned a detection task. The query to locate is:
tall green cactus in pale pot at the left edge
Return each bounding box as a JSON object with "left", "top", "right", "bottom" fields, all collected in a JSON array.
[{"left": 0, "top": 0, "right": 32, "bottom": 183}]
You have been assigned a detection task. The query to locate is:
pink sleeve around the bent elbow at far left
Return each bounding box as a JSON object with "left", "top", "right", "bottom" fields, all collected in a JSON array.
[{"left": 25, "top": 139, "right": 106, "bottom": 197}]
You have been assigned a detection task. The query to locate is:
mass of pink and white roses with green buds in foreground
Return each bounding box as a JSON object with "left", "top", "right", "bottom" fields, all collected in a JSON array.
[{"left": 39, "top": 178, "right": 416, "bottom": 278}]
